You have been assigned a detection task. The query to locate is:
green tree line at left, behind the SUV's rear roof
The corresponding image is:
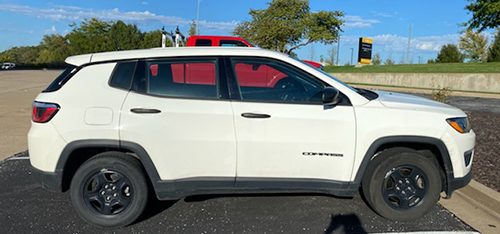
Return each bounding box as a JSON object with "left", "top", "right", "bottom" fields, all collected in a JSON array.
[{"left": 0, "top": 18, "right": 171, "bottom": 68}]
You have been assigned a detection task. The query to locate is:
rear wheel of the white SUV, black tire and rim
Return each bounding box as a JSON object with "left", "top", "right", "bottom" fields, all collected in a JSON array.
[{"left": 70, "top": 152, "right": 149, "bottom": 228}]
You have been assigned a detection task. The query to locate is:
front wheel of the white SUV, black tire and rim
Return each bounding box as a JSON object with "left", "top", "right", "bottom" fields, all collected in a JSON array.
[{"left": 362, "top": 148, "right": 442, "bottom": 221}]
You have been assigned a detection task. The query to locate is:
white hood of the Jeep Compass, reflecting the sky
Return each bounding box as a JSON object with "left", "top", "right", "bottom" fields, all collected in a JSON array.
[{"left": 373, "top": 91, "right": 463, "bottom": 113}]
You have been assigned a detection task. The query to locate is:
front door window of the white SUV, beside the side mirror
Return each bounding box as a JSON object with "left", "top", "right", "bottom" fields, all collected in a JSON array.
[{"left": 232, "top": 59, "right": 324, "bottom": 104}]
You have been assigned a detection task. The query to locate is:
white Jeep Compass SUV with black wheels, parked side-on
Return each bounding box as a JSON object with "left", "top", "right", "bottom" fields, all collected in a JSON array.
[{"left": 28, "top": 47, "right": 475, "bottom": 227}]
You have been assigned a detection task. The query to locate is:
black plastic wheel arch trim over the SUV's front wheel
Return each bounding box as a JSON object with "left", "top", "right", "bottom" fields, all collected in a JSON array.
[{"left": 354, "top": 136, "right": 454, "bottom": 196}]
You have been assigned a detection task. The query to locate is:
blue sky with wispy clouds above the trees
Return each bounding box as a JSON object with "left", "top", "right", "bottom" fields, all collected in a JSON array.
[{"left": 0, "top": 0, "right": 493, "bottom": 65}]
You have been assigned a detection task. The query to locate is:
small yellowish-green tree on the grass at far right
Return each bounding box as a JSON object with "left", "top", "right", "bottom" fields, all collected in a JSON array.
[{"left": 459, "top": 30, "right": 488, "bottom": 62}]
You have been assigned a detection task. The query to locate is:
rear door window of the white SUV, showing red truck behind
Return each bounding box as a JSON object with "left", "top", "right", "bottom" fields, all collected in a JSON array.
[{"left": 145, "top": 59, "right": 218, "bottom": 98}]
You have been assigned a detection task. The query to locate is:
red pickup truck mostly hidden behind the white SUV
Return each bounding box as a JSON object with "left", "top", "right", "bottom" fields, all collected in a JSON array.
[{"left": 186, "top": 36, "right": 323, "bottom": 70}]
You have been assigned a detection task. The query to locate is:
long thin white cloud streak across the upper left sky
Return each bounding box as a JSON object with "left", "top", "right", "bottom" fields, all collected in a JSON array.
[{"left": 0, "top": 4, "right": 238, "bottom": 32}]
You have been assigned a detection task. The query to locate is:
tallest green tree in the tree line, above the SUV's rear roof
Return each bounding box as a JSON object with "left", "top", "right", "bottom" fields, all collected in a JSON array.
[{"left": 66, "top": 18, "right": 116, "bottom": 55}]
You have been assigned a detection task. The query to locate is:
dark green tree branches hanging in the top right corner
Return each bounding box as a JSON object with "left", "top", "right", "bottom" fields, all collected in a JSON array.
[{"left": 464, "top": 0, "right": 500, "bottom": 32}]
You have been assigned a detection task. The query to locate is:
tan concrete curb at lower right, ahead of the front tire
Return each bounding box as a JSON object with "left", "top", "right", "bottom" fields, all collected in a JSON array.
[{"left": 439, "top": 180, "right": 500, "bottom": 234}]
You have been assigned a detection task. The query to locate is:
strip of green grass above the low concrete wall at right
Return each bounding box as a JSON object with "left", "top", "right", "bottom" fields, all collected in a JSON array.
[{"left": 325, "top": 62, "right": 500, "bottom": 73}]
